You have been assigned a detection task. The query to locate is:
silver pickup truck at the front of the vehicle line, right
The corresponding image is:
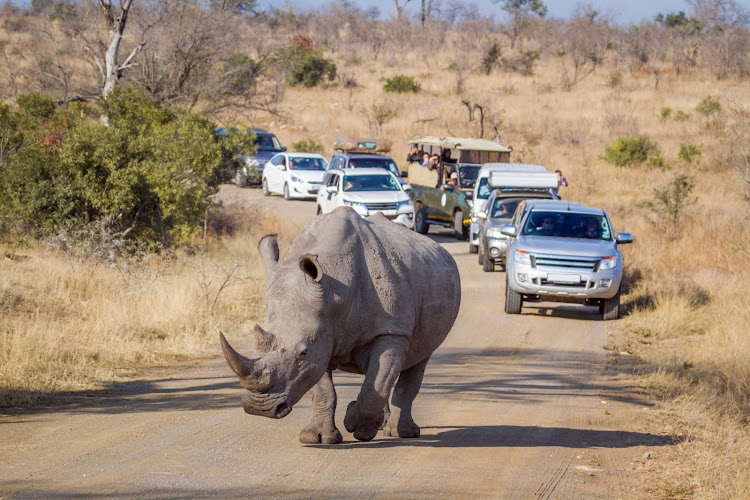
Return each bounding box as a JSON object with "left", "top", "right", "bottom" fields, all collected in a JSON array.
[{"left": 501, "top": 200, "right": 633, "bottom": 320}]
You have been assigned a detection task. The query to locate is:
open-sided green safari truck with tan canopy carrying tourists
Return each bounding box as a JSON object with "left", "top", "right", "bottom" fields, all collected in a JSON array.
[{"left": 408, "top": 135, "right": 513, "bottom": 240}]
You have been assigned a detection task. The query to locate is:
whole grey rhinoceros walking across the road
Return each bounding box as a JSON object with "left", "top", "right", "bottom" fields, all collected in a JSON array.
[{"left": 220, "top": 207, "right": 461, "bottom": 444}]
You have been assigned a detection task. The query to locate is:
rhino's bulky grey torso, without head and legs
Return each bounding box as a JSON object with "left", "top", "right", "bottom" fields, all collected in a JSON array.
[{"left": 283, "top": 207, "right": 461, "bottom": 364}]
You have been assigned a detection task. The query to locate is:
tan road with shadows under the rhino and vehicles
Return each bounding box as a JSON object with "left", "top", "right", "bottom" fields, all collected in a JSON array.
[{"left": 0, "top": 186, "right": 674, "bottom": 499}]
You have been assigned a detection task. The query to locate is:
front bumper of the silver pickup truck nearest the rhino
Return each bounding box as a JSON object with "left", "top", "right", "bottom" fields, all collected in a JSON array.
[{"left": 507, "top": 266, "right": 622, "bottom": 302}]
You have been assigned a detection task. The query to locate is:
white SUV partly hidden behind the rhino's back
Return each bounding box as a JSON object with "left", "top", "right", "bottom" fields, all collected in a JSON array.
[{"left": 317, "top": 168, "right": 414, "bottom": 229}]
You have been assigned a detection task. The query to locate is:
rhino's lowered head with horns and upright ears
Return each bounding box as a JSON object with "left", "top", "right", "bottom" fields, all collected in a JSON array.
[{"left": 220, "top": 235, "right": 333, "bottom": 418}]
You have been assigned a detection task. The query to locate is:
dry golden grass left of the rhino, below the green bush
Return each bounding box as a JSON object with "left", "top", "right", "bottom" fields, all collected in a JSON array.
[{"left": 0, "top": 206, "right": 294, "bottom": 406}]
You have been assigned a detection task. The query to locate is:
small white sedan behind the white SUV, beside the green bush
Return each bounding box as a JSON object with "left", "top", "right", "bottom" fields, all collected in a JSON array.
[{"left": 262, "top": 153, "right": 328, "bottom": 200}]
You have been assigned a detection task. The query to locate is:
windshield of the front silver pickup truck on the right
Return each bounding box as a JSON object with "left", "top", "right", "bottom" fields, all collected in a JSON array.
[{"left": 522, "top": 211, "right": 612, "bottom": 241}]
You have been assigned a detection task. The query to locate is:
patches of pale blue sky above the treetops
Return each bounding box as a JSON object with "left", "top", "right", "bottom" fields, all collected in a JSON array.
[{"left": 258, "top": 0, "right": 704, "bottom": 24}]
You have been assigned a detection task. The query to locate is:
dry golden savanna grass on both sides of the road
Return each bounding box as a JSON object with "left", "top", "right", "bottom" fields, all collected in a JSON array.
[{"left": 0, "top": 2, "right": 750, "bottom": 498}]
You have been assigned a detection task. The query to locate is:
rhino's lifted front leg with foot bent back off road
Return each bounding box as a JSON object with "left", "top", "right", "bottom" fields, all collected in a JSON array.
[{"left": 344, "top": 335, "right": 409, "bottom": 441}]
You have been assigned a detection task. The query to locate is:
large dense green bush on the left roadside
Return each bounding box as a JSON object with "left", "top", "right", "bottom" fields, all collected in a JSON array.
[{"left": 0, "top": 87, "right": 222, "bottom": 245}]
